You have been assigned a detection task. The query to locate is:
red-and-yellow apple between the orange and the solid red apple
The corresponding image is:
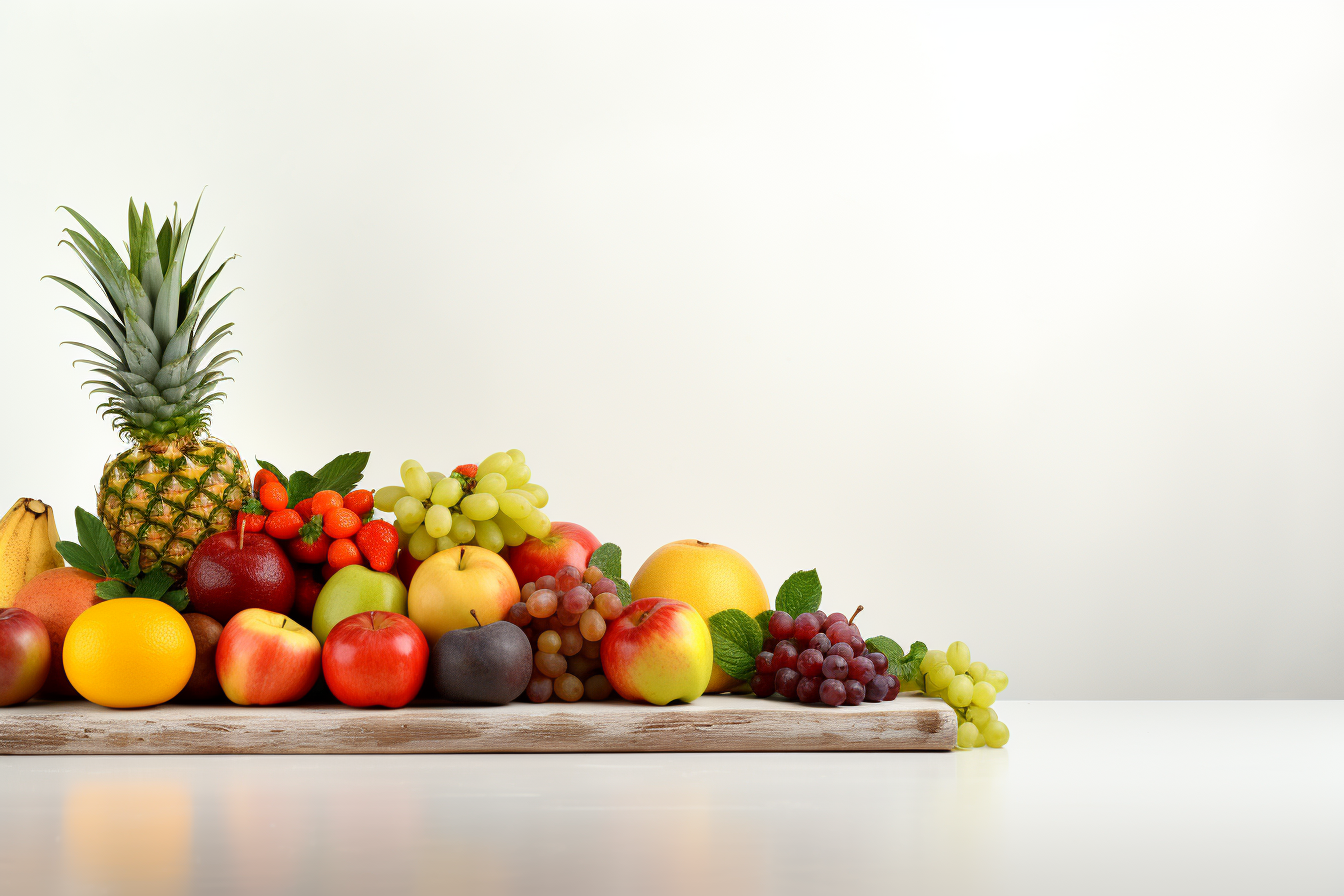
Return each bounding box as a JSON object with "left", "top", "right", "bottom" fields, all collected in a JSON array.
[{"left": 215, "top": 609, "right": 323, "bottom": 707}]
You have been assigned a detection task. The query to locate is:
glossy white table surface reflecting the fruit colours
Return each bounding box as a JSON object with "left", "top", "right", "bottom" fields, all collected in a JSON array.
[{"left": 0, "top": 700, "right": 1344, "bottom": 896}]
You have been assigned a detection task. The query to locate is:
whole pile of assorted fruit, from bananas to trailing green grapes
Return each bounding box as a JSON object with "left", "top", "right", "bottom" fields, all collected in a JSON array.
[{"left": 0, "top": 190, "right": 1008, "bottom": 748}]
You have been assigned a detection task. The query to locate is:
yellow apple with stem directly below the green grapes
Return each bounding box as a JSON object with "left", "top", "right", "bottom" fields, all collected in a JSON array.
[{"left": 406, "top": 544, "right": 519, "bottom": 643}]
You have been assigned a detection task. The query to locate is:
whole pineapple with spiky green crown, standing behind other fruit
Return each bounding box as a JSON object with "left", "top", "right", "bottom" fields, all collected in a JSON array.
[{"left": 51, "top": 193, "right": 251, "bottom": 580}]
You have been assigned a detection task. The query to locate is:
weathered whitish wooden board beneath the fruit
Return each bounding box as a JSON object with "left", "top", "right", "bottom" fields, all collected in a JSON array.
[{"left": 0, "top": 695, "right": 957, "bottom": 755}]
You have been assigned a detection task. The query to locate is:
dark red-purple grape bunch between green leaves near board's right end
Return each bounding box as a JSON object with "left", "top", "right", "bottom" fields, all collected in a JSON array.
[{"left": 751, "top": 607, "right": 900, "bottom": 707}]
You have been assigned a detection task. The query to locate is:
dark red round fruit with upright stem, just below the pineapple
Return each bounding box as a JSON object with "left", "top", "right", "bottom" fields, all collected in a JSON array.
[{"left": 187, "top": 531, "right": 294, "bottom": 625}]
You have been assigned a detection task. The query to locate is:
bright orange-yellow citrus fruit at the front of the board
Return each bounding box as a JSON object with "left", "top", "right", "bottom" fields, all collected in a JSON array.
[{"left": 62, "top": 598, "right": 196, "bottom": 709}]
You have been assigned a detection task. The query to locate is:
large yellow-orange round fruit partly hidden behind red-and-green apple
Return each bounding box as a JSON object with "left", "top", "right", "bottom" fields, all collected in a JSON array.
[{"left": 630, "top": 539, "right": 770, "bottom": 693}]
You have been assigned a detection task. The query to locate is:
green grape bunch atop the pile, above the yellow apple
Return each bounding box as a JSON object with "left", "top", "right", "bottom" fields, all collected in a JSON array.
[{"left": 374, "top": 449, "right": 551, "bottom": 560}]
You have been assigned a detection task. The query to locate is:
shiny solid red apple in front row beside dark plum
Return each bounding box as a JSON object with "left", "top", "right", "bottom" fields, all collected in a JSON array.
[{"left": 323, "top": 609, "right": 429, "bottom": 709}]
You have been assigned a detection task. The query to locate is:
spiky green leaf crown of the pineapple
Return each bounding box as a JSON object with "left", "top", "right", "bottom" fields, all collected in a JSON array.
[{"left": 48, "top": 190, "right": 241, "bottom": 445}]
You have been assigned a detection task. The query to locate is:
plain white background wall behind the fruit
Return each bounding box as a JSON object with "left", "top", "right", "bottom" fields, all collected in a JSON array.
[{"left": 0, "top": 3, "right": 1344, "bottom": 697}]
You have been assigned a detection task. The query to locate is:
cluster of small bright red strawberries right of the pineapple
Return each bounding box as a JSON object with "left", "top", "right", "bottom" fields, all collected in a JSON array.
[{"left": 238, "top": 469, "right": 398, "bottom": 615}]
